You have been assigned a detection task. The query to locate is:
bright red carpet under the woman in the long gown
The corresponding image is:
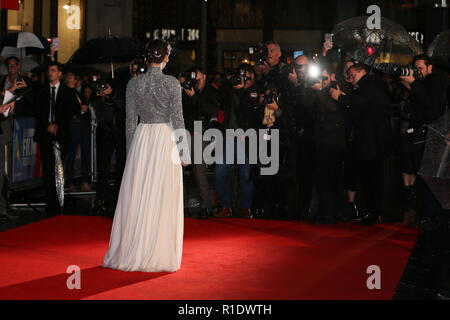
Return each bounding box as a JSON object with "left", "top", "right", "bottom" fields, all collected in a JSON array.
[{"left": 0, "top": 216, "right": 418, "bottom": 300}]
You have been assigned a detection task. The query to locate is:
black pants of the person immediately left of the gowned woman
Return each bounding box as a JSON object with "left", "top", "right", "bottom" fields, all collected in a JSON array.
[{"left": 97, "top": 123, "right": 126, "bottom": 211}]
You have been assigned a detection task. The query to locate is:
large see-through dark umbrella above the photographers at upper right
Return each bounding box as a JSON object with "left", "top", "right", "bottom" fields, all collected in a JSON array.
[{"left": 333, "top": 16, "right": 423, "bottom": 73}]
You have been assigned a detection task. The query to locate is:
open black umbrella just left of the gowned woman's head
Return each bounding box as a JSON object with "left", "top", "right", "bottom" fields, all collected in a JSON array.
[{"left": 69, "top": 35, "right": 143, "bottom": 65}]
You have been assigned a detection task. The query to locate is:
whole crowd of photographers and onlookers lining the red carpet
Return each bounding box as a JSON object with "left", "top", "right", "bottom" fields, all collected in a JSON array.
[{"left": 0, "top": 41, "right": 448, "bottom": 228}]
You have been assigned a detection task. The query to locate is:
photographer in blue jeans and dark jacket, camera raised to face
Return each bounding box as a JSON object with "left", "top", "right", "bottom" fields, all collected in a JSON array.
[{"left": 215, "top": 65, "right": 258, "bottom": 218}]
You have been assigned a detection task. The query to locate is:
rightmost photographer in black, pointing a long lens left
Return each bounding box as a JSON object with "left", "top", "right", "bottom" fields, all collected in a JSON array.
[{"left": 400, "top": 54, "right": 447, "bottom": 229}]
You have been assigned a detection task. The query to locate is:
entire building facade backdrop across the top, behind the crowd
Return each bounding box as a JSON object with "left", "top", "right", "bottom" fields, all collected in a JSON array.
[{"left": 0, "top": 0, "right": 449, "bottom": 71}]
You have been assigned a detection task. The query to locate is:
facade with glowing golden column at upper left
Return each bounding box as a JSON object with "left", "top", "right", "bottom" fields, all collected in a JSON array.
[{"left": 0, "top": 0, "right": 133, "bottom": 63}]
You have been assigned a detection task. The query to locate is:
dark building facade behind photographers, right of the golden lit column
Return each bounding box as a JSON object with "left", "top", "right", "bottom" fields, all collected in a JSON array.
[{"left": 133, "top": 0, "right": 448, "bottom": 71}]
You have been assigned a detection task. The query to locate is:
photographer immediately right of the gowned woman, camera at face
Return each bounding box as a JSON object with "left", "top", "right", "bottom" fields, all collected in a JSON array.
[{"left": 179, "top": 67, "right": 220, "bottom": 219}]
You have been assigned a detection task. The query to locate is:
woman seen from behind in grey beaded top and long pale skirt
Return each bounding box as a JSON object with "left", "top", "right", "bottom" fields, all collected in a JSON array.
[{"left": 103, "top": 40, "right": 190, "bottom": 272}]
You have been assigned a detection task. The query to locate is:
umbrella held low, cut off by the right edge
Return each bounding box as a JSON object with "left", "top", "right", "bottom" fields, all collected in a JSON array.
[{"left": 419, "top": 113, "right": 450, "bottom": 209}]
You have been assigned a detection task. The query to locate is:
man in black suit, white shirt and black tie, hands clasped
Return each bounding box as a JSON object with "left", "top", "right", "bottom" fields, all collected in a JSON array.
[{"left": 34, "top": 62, "right": 80, "bottom": 217}]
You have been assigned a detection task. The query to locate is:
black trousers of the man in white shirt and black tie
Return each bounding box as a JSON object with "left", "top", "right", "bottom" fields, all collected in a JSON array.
[{"left": 38, "top": 133, "right": 66, "bottom": 216}]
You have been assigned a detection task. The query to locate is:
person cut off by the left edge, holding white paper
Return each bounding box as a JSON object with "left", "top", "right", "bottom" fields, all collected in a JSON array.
[{"left": 0, "top": 93, "right": 15, "bottom": 223}]
